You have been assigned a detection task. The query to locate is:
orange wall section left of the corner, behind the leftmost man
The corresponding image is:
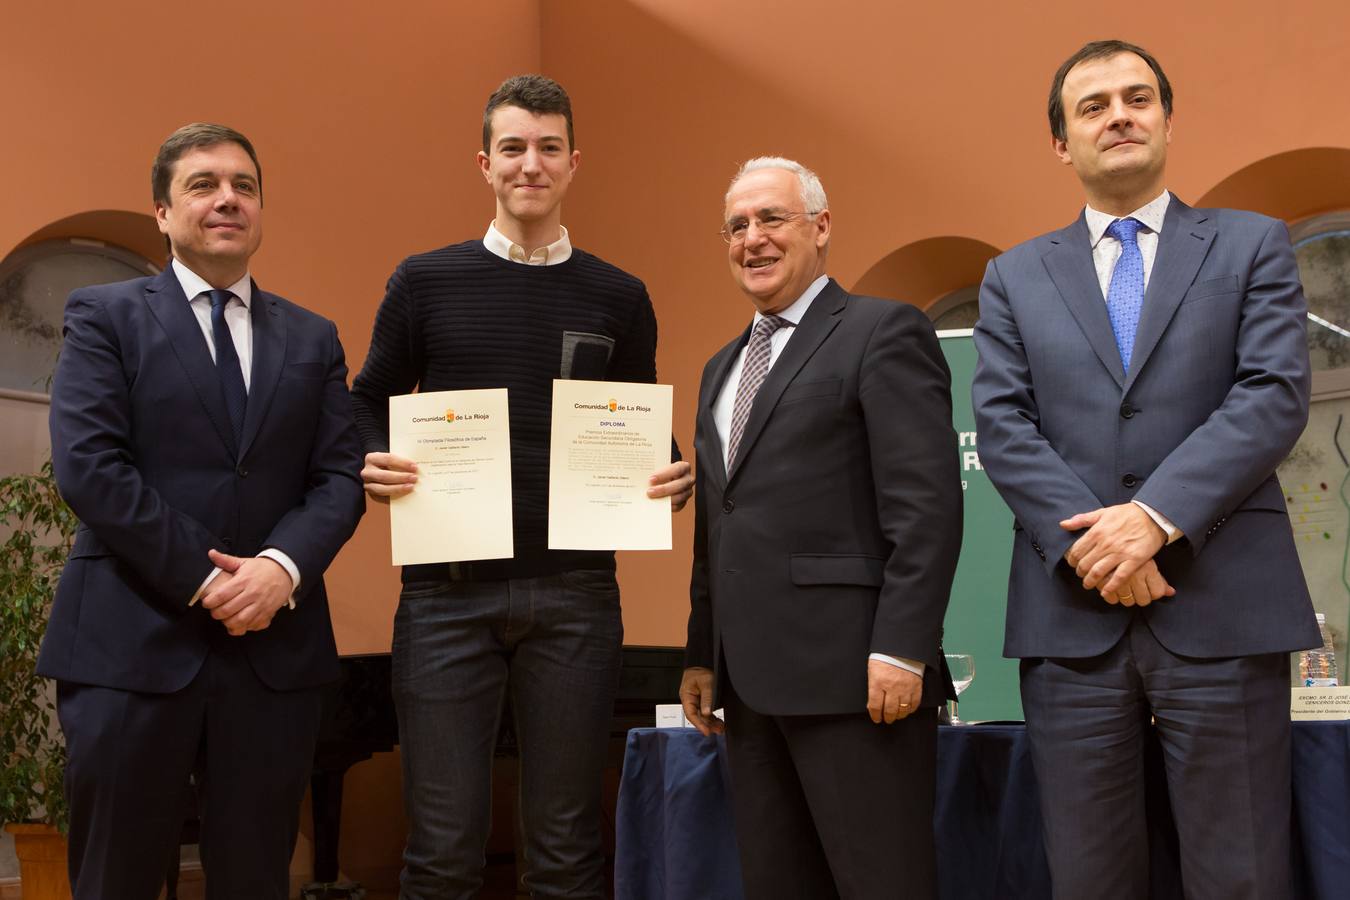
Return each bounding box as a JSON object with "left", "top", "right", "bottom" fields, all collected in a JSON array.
[{"left": 0, "top": 0, "right": 540, "bottom": 661}]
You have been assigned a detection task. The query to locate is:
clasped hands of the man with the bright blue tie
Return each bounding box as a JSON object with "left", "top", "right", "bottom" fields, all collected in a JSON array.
[{"left": 1060, "top": 503, "right": 1176, "bottom": 606}]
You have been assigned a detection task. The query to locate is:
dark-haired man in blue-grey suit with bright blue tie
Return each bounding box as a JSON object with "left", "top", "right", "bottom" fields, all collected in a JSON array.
[{"left": 973, "top": 40, "right": 1319, "bottom": 900}]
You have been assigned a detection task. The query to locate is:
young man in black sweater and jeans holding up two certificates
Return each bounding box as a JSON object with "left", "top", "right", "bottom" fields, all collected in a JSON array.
[{"left": 352, "top": 76, "right": 694, "bottom": 900}]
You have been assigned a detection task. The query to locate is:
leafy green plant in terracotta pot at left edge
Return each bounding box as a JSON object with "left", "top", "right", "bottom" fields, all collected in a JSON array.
[{"left": 0, "top": 461, "right": 77, "bottom": 900}]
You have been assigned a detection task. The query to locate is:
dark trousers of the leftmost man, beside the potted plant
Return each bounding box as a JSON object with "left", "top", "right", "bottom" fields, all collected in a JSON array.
[{"left": 57, "top": 641, "right": 321, "bottom": 900}]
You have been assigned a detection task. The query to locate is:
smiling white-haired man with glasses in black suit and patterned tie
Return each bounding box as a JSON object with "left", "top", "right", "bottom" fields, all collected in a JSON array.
[{"left": 680, "top": 158, "right": 961, "bottom": 900}]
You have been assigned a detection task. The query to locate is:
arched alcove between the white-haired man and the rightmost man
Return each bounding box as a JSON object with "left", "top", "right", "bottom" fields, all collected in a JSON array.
[{"left": 853, "top": 236, "right": 999, "bottom": 314}]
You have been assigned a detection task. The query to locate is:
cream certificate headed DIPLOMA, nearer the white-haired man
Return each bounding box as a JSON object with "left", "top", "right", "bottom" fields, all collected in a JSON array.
[{"left": 548, "top": 381, "right": 674, "bottom": 551}]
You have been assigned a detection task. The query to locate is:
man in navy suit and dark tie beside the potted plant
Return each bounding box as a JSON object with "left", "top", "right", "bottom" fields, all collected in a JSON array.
[{"left": 38, "top": 124, "right": 365, "bottom": 900}]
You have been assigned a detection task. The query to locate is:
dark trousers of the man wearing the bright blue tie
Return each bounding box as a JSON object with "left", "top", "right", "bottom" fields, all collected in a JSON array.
[{"left": 1022, "top": 617, "right": 1292, "bottom": 900}]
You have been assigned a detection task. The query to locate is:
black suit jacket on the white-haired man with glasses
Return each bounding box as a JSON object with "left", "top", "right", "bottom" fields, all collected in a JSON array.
[{"left": 686, "top": 281, "right": 961, "bottom": 715}]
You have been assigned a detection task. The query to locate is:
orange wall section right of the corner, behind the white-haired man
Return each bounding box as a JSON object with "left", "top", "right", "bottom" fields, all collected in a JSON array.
[{"left": 541, "top": 0, "right": 1350, "bottom": 644}]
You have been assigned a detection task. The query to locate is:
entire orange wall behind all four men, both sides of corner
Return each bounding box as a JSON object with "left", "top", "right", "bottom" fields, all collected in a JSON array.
[{"left": 10, "top": 0, "right": 1350, "bottom": 881}]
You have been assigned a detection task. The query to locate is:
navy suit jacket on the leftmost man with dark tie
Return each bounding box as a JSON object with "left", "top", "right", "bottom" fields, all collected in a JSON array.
[{"left": 38, "top": 267, "right": 365, "bottom": 692}]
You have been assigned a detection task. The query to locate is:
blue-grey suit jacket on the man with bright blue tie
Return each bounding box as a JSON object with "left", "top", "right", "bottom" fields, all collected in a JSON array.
[{"left": 972, "top": 197, "right": 1320, "bottom": 657}]
